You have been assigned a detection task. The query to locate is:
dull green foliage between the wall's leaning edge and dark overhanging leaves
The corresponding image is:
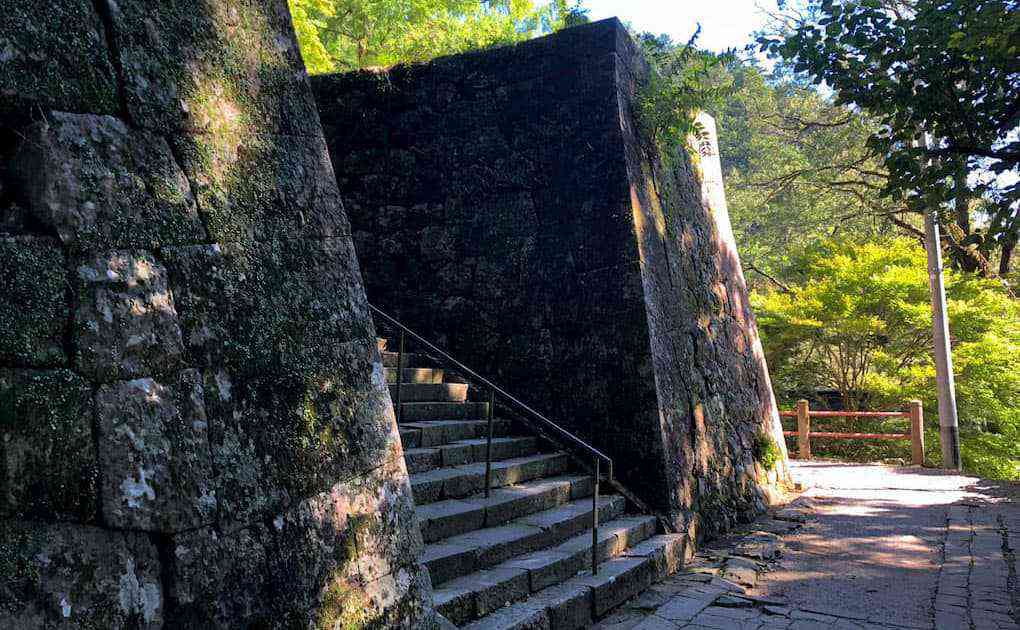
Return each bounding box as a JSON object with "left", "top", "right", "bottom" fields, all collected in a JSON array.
[{"left": 712, "top": 61, "right": 897, "bottom": 286}]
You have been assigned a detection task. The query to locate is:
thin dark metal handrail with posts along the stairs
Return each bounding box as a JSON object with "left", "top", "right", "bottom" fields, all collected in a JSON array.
[{"left": 368, "top": 304, "right": 614, "bottom": 574}]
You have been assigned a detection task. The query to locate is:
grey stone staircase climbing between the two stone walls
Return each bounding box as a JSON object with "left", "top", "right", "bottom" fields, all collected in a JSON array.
[{"left": 379, "top": 339, "right": 683, "bottom": 630}]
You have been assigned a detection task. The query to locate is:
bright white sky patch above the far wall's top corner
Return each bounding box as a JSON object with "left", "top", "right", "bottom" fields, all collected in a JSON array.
[{"left": 582, "top": 0, "right": 775, "bottom": 51}]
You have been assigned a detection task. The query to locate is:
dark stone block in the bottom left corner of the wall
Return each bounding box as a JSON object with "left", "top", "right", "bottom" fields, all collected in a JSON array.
[{"left": 0, "top": 521, "right": 164, "bottom": 630}]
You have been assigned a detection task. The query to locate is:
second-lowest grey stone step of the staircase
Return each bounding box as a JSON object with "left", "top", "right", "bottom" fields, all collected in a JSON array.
[{"left": 434, "top": 517, "right": 656, "bottom": 628}]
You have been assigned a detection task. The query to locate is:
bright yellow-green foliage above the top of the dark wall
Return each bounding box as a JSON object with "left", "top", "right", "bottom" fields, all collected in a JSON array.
[{"left": 289, "top": 0, "right": 587, "bottom": 73}]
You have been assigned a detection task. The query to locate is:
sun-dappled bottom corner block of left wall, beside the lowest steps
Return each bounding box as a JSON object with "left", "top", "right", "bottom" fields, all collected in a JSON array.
[{"left": 269, "top": 449, "right": 431, "bottom": 628}]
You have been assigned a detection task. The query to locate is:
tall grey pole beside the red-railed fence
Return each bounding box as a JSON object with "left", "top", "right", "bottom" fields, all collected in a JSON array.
[{"left": 924, "top": 212, "right": 961, "bottom": 470}]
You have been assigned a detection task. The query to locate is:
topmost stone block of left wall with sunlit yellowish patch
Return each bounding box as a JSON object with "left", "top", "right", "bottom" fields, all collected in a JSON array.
[{"left": 103, "top": 0, "right": 320, "bottom": 136}]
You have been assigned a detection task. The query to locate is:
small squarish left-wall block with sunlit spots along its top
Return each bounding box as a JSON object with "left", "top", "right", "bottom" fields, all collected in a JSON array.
[{"left": 73, "top": 250, "right": 184, "bottom": 381}]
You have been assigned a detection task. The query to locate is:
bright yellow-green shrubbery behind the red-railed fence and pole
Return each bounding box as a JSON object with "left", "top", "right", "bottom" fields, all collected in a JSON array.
[{"left": 752, "top": 239, "right": 1020, "bottom": 477}]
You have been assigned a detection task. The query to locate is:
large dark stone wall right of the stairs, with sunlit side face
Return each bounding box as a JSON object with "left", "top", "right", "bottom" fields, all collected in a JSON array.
[{"left": 312, "top": 19, "right": 785, "bottom": 536}]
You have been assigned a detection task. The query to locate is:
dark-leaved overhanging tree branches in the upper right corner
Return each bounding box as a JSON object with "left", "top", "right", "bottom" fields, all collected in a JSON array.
[{"left": 759, "top": 0, "right": 1020, "bottom": 277}]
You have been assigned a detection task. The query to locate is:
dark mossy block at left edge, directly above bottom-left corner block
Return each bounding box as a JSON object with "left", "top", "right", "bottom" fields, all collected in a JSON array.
[{"left": 0, "top": 369, "right": 98, "bottom": 523}]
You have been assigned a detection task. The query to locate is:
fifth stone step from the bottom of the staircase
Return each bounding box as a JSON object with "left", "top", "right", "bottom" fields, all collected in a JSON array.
[{"left": 411, "top": 453, "right": 571, "bottom": 507}]
